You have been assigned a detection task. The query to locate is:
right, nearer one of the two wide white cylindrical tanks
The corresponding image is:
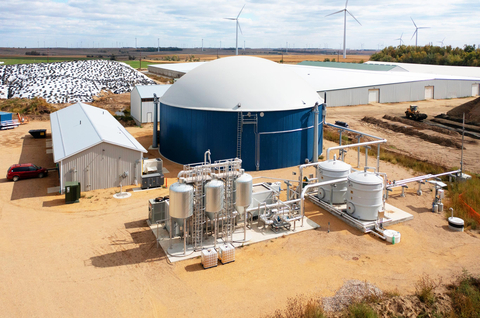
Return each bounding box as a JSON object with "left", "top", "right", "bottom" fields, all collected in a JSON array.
[{"left": 347, "top": 171, "right": 383, "bottom": 221}]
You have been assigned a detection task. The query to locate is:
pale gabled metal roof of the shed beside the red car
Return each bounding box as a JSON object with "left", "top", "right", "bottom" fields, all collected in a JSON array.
[{"left": 50, "top": 102, "right": 147, "bottom": 162}]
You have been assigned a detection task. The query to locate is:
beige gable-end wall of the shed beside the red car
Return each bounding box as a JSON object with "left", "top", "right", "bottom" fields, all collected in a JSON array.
[{"left": 60, "top": 143, "right": 142, "bottom": 191}]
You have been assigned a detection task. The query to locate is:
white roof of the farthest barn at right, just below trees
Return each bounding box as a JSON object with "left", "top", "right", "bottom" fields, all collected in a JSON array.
[{"left": 366, "top": 61, "right": 480, "bottom": 78}]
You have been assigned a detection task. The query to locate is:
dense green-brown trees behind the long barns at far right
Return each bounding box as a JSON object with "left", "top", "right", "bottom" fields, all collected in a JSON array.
[{"left": 370, "top": 44, "right": 480, "bottom": 66}]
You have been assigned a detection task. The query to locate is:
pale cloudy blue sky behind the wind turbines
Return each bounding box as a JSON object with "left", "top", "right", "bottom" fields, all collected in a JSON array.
[{"left": 0, "top": 0, "right": 480, "bottom": 49}]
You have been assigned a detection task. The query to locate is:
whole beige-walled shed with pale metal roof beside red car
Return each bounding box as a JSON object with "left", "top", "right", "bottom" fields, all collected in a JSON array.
[{"left": 50, "top": 103, "right": 147, "bottom": 192}]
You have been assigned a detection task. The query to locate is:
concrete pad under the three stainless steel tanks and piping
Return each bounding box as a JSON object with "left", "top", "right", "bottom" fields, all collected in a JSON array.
[{"left": 147, "top": 217, "right": 320, "bottom": 263}]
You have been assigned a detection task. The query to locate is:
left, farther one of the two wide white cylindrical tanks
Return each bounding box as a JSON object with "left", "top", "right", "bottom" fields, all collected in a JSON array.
[{"left": 317, "top": 158, "right": 352, "bottom": 204}]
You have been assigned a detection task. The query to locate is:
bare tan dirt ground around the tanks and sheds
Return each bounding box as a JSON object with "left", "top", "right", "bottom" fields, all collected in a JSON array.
[{"left": 0, "top": 100, "right": 480, "bottom": 317}]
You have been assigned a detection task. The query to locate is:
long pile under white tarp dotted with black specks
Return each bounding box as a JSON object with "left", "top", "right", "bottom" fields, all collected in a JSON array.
[{"left": 0, "top": 60, "right": 155, "bottom": 103}]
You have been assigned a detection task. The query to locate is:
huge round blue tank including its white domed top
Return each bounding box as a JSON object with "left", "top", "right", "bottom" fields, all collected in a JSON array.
[{"left": 159, "top": 56, "right": 323, "bottom": 171}]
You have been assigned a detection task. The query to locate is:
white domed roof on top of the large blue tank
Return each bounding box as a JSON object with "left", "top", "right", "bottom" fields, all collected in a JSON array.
[{"left": 160, "top": 56, "right": 323, "bottom": 112}]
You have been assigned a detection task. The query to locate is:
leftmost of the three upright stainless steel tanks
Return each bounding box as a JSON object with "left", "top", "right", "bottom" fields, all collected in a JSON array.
[{"left": 169, "top": 179, "right": 193, "bottom": 219}]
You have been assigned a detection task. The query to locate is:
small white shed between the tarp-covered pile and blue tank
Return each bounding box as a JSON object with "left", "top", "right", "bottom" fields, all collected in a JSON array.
[{"left": 130, "top": 85, "right": 172, "bottom": 125}]
